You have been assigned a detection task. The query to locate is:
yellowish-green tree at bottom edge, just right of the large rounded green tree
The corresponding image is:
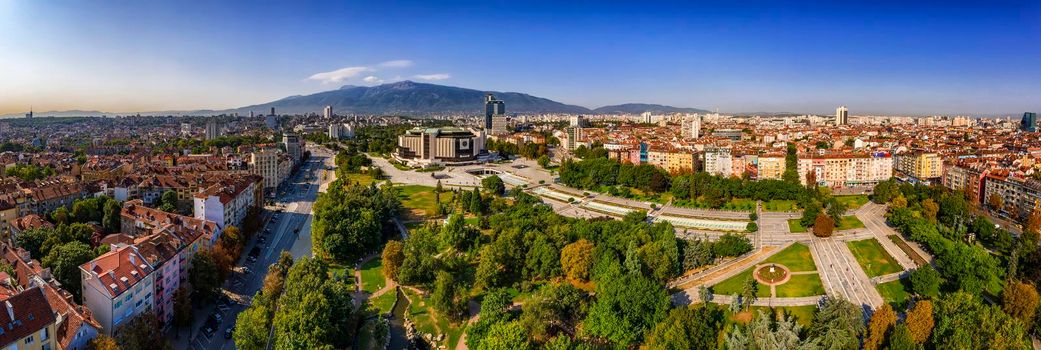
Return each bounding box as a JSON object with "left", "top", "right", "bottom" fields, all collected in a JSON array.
[{"left": 646, "top": 305, "right": 725, "bottom": 350}]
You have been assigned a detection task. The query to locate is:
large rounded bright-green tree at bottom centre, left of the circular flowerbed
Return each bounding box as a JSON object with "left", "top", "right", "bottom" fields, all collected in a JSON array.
[{"left": 583, "top": 274, "right": 669, "bottom": 345}]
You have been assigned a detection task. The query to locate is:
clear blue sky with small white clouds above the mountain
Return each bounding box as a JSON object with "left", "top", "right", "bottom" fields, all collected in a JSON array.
[{"left": 0, "top": 0, "right": 1041, "bottom": 115}]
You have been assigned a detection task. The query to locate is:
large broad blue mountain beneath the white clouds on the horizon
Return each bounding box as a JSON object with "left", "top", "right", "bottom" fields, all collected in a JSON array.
[{"left": 219, "top": 80, "right": 590, "bottom": 115}]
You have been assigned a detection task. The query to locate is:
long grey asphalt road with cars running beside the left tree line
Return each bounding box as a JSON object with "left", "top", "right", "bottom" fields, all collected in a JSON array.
[{"left": 173, "top": 148, "right": 333, "bottom": 350}]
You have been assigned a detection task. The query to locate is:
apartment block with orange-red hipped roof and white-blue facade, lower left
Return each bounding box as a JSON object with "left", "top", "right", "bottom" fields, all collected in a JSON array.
[{"left": 79, "top": 246, "right": 155, "bottom": 335}]
